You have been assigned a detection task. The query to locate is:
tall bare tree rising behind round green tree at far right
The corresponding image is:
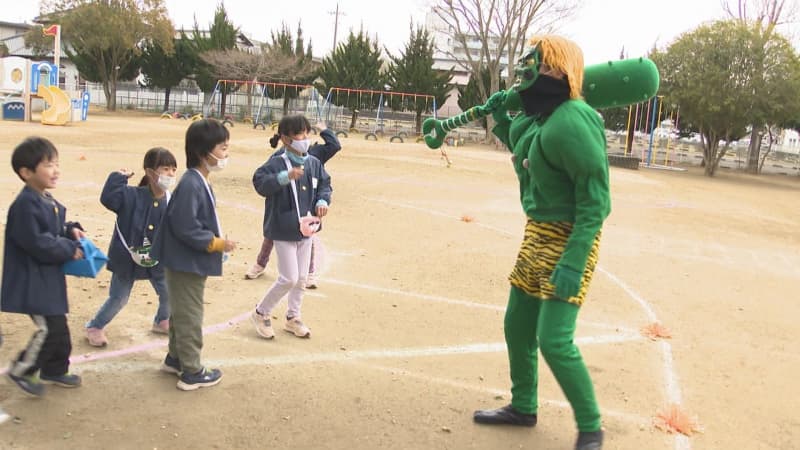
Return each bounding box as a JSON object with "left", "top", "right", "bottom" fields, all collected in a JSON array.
[{"left": 722, "top": 0, "right": 800, "bottom": 173}]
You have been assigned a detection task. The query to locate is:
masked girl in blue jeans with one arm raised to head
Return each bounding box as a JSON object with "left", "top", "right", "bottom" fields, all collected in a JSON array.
[{"left": 86, "top": 147, "right": 178, "bottom": 347}]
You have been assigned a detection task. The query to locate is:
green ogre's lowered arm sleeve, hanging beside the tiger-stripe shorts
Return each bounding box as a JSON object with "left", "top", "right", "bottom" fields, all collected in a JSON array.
[{"left": 542, "top": 104, "right": 611, "bottom": 273}]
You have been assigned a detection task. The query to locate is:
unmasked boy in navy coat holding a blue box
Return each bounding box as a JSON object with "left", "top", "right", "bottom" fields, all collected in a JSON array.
[{"left": 0, "top": 137, "right": 84, "bottom": 396}]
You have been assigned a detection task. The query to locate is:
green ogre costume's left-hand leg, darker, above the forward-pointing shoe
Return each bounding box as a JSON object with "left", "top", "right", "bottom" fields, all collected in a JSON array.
[{"left": 504, "top": 286, "right": 542, "bottom": 414}]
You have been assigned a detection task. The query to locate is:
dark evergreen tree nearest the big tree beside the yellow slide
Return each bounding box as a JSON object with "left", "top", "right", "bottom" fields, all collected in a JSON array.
[{"left": 140, "top": 39, "right": 195, "bottom": 111}]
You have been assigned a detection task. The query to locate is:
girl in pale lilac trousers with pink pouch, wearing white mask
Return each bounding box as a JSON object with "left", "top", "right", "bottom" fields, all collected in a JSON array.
[{"left": 251, "top": 115, "right": 331, "bottom": 339}]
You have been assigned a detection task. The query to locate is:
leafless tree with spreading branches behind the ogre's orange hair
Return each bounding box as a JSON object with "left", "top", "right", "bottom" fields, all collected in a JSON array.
[{"left": 433, "top": 0, "right": 579, "bottom": 127}]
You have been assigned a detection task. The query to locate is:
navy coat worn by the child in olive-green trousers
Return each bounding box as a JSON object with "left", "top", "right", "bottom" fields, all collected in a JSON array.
[{"left": 150, "top": 169, "right": 222, "bottom": 276}]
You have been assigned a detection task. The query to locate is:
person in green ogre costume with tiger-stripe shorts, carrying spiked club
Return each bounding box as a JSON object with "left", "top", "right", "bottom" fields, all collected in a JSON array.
[{"left": 422, "top": 35, "right": 659, "bottom": 450}]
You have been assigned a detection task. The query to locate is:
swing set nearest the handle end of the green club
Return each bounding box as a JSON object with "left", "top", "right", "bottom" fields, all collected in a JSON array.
[{"left": 320, "top": 87, "right": 438, "bottom": 143}]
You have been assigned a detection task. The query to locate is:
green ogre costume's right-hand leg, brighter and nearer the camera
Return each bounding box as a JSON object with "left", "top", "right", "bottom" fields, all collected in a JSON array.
[{"left": 539, "top": 299, "right": 600, "bottom": 431}]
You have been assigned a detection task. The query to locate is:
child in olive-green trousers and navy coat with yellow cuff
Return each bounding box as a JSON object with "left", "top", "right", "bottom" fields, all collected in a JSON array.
[{"left": 151, "top": 119, "right": 236, "bottom": 391}]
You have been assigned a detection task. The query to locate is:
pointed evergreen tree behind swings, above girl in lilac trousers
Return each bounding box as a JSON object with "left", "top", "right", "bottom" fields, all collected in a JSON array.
[{"left": 319, "top": 29, "right": 384, "bottom": 128}]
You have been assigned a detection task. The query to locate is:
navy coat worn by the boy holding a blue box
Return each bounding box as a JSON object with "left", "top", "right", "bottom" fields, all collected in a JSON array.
[{"left": 0, "top": 186, "right": 80, "bottom": 316}]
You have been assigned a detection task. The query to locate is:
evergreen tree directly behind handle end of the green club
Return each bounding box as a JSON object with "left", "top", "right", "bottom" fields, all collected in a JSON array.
[{"left": 387, "top": 23, "right": 453, "bottom": 134}]
